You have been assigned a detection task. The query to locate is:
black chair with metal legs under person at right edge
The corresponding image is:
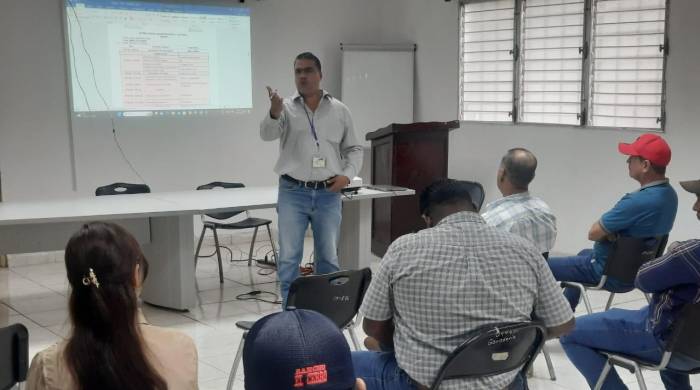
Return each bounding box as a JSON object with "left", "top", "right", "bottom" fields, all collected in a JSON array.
[{"left": 595, "top": 303, "right": 700, "bottom": 390}]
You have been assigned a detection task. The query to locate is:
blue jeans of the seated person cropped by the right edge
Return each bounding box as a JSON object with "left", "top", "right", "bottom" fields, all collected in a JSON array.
[{"left": 559, "top": 306, "right": 700, "bottom": 390}]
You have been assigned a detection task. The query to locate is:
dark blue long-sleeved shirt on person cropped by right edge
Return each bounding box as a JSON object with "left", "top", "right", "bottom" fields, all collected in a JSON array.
[{"left": 634, "top": 240, "right": 700, "bottom": 344}]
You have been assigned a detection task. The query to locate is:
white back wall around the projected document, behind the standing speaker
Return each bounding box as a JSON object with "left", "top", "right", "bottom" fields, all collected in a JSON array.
[{"left": 0, "top": 0, "right": 379, "bottom": 200}]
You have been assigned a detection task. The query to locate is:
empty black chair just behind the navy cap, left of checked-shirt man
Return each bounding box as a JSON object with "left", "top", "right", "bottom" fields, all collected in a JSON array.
[{"left": 226, "top": 268, "right": 372, "bottom": 390}]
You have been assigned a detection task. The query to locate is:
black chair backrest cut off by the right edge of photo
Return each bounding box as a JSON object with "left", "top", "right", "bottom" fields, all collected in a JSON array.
[{"left": 665, "top": 303, "right": 700, "bottom": 361}]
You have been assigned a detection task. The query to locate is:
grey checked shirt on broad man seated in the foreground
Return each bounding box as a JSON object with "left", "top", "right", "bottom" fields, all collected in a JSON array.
[{"left": 360, "top": 212, "right": 573, "bottom": 390}]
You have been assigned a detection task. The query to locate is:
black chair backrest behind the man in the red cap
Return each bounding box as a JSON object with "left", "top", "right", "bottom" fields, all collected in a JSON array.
[{"left": 604, "top": 235, "right": 668, "bottom": 284}]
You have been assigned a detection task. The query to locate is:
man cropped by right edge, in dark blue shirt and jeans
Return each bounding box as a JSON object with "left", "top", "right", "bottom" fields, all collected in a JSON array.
[{"left": 559, "top": 180, "right": 700, "bottom": 390}]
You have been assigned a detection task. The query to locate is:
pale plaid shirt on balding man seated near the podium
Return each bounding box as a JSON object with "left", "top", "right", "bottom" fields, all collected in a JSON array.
[{"left": 481, "top": 192, "right": 557, "bottom": 253}]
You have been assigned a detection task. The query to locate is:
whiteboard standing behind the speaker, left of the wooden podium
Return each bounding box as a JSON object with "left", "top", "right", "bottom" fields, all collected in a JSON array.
[{"left": 341, "top": 44, "right": 416, "bottom": 147}]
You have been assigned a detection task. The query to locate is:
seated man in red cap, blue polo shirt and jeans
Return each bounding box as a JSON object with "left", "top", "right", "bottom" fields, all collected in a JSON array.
[{"left": 548, "top": 134, "right": 678, "bottom": 310}]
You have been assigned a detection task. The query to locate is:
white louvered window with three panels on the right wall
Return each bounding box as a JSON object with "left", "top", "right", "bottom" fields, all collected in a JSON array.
[{"left": 460, "top": 0, "right": 669, "bottom": 129}]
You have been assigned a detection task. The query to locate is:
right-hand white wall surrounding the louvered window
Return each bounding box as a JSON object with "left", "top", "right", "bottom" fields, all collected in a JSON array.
[{"left": 381, "top": 0, "right": 700, "bottom": 252}]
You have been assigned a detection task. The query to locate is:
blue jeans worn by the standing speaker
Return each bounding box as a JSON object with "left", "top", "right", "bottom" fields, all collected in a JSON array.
[{"left": 277, "top": 178, "right": 342, "bottom": 307}]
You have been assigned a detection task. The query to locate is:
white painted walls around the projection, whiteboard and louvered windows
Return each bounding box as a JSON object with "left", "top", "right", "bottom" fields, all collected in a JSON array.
[{"left": 0, "top": 0, "right": 700, "bottom": 252}]
